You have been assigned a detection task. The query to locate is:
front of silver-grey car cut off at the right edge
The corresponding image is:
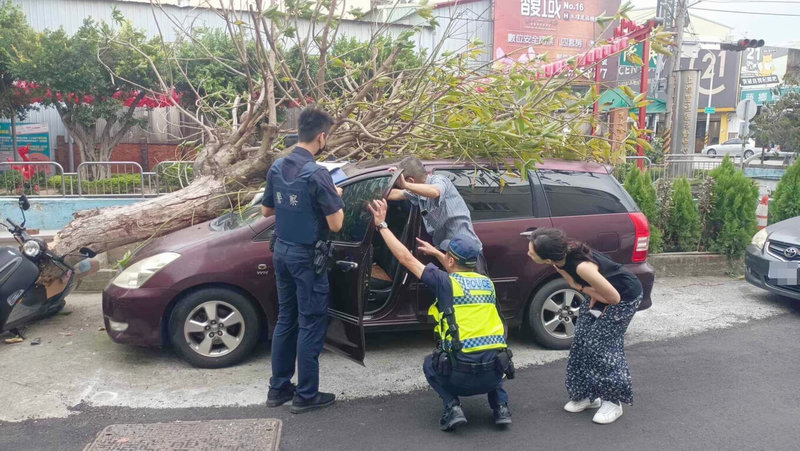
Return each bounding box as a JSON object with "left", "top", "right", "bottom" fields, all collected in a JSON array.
[{"left": 744, "top": 216, "right": 800, "bottom": 300}]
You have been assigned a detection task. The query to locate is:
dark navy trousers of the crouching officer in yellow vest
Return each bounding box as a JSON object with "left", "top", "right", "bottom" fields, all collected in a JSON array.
[{"left": 422, "top": 355, "right": 508, "bottom": 409}]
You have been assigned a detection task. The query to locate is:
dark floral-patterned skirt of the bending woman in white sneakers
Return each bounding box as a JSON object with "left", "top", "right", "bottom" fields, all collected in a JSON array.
[{"left": 566, "top": 295, "right": 642, "bottom": 404}]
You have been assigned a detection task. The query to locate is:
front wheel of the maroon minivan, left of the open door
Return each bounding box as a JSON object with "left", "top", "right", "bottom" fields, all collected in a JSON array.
[{"left": 169, "top": 288, "right": 263, "bottom": 368}]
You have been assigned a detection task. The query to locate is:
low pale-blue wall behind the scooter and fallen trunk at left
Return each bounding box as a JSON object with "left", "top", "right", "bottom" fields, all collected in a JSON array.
[{"left": 0, "top": 197, "right": 143, "bottom": 230}]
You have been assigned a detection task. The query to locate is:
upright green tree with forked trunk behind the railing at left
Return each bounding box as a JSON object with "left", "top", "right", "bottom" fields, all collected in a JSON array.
[{"left": 14, "top": 12, "right": 171, "bottom": 176}]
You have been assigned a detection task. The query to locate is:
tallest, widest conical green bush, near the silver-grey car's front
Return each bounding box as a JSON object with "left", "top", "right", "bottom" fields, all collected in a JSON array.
[{"left": 703, "top": 156, "right": 758, "bottom": 259}]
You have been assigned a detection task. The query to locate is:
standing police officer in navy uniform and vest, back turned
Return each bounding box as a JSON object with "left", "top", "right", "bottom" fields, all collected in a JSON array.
[{"left": 262, "top": 108, "right": 344, "bottom": 413}]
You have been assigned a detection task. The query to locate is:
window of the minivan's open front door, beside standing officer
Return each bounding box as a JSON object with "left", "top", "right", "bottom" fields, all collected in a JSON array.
[{"left": 330, "top": 176, "right": 391, "bottom": 243}]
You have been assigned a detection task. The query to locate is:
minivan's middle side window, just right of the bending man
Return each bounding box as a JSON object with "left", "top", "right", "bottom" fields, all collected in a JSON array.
[{"left": 436, "top": 169, "right": 533, "bottom": 221}]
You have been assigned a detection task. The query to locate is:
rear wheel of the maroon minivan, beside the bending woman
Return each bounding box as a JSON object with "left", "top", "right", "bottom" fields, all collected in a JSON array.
[{"left": 526, "top": 278, "right": 583, "bottom": 349}]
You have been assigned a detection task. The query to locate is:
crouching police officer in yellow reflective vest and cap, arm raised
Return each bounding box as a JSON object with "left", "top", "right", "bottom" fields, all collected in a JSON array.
[{"left": 369, "top": 200, "right": 514, "bottom": 431}]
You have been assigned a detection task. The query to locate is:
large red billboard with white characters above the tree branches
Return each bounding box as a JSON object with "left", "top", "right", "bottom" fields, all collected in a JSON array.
[{"left": 494, "top": 0, "right": 620, "bottom": 62}]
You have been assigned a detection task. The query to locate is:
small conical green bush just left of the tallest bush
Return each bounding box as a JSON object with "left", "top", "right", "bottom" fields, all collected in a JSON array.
[{"left": 664, "top": 178, "right": 700, "bottom": 252}]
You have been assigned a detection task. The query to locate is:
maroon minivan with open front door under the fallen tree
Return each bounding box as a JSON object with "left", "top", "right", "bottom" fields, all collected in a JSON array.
[{"left": 103, "top": 161, "right": 655, "bottom": 367}]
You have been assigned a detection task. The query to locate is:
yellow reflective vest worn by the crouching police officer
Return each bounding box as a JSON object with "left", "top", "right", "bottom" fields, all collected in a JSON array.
[{"left": 428, "top": 272, "right": 506, "bottom": 353}]
